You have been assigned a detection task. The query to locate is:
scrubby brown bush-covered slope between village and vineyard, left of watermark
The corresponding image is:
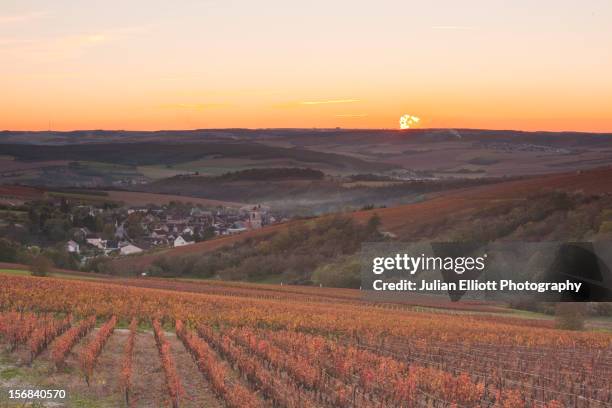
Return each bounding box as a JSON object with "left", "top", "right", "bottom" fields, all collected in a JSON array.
[{"left": 144, "top": 215, "right": 381, "bottom": 287}]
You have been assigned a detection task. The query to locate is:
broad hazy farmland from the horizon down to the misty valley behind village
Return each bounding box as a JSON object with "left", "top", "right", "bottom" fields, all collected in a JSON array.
[{"left": 0, "top": 129, "right": 612, "bottom": 217}]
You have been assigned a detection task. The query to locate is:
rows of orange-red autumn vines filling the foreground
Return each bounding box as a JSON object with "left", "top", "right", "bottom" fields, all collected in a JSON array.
[{"left": 0, "top": 275, "right": 612, "bottom": 408}]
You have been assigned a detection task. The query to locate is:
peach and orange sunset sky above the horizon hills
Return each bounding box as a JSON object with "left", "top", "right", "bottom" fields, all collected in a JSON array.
[{"left": 0, "top": 0, "right": 612, "bottom": 132}]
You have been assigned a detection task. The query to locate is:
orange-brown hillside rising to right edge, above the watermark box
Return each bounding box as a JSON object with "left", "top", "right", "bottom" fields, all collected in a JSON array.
[{"left": 353, "top": 167, "right": 612, "bottom": 240}]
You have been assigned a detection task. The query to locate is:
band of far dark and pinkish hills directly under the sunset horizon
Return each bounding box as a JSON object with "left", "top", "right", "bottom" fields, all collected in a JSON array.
[{"left": 0, "top": 129, "right": 612, "bottom": 179}]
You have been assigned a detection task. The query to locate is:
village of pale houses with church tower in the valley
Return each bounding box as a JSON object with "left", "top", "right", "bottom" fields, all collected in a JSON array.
[{"left": 64, "top": 202, "right": 278, "bottom": 262}]
